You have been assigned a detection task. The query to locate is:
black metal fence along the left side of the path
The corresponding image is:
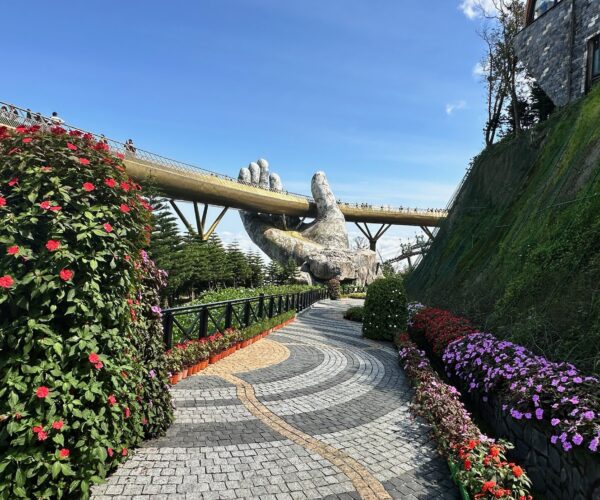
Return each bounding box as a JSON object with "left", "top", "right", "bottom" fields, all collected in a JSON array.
[{"left": 163, "top": 289, "right": 328, "bottom": 349}]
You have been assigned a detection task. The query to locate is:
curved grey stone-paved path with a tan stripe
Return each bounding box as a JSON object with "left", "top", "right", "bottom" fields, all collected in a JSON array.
[{"left": 93, "top": 300, "right": 457, "bottom": 500}]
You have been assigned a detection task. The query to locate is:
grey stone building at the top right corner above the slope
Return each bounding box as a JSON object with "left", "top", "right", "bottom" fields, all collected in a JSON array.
[{"left": 515, "top": 0, "right": 600, "bottom": 106}]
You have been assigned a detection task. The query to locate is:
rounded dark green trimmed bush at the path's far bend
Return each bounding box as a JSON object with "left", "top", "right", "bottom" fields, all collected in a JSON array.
[{"left": 363, "top": 276, "right": 407, "bottom": 340}]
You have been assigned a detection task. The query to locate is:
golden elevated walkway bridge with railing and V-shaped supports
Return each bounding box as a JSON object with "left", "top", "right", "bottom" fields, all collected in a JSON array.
[{"left": 0, "top": 101, "right": 447, "bottom": 249}]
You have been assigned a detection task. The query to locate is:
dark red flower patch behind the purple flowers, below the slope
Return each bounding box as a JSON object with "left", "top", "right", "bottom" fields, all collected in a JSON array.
[{"left": 410, "top": 307, "right": 474, "bottom": 355}]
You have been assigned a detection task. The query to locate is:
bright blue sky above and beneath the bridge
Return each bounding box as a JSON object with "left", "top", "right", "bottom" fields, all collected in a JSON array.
[{"left": 0, "top": 0, "right": 484, "bottom": 258}]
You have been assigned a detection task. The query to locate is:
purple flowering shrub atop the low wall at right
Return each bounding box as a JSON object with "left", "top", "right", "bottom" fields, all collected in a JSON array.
[{"left": 443, "top": 333, "right": 600, "bottom": 452}]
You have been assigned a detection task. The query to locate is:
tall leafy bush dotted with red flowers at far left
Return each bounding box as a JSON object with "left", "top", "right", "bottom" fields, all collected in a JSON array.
[{"left": 0, "top": 127, "right": 172, "bottom": 498}]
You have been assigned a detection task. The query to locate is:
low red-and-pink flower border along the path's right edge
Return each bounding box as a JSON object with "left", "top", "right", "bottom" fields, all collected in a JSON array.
[{"left": 397, "top": 334, "right": 531, "bottom": 500}]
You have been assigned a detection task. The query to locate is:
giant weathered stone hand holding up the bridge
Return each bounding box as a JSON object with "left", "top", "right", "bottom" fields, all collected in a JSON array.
[{"left": 238, "top": 159, "right": 378, "bottom": 284}]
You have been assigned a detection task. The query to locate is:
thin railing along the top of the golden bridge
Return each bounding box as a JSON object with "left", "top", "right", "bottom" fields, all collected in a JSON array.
[{"left": 0, "top": 101, "right": 445, "bottom": 216}]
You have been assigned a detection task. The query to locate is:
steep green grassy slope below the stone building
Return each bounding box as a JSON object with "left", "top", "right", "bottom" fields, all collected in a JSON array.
[{"left": 407, "top": 85, "right": 600, "bottom": 374}]
